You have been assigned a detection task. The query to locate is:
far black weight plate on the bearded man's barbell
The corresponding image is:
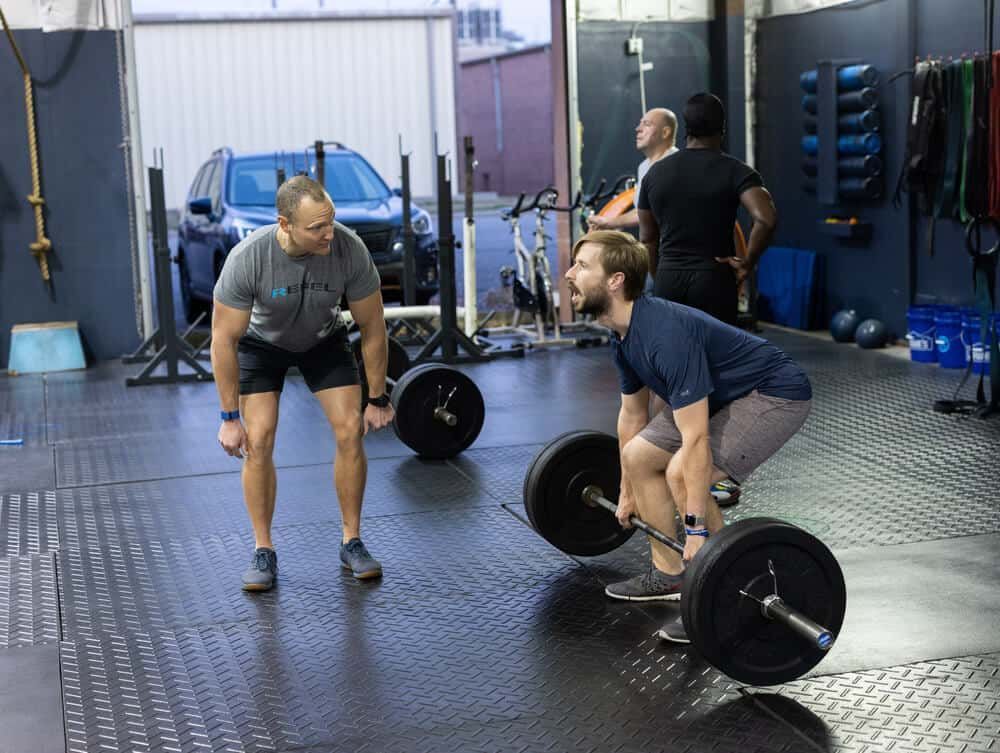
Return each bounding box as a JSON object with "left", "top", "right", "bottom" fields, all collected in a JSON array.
[{"left": 524, "top": 431, "right": 635, "bottom": 557}]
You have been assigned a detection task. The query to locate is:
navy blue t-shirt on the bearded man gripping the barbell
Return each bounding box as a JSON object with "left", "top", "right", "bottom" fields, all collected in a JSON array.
[{"left": 611, "top": 295, "right": 812, "bottom": 413}]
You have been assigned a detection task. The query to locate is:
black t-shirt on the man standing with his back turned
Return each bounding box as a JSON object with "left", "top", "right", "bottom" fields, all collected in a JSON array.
[{"left": 636, "top": 149, "right": 764, "bottom": 270}]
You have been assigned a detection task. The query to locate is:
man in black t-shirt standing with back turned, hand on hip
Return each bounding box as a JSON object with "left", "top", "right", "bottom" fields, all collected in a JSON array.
[{"left": 636, "top": 93, "right": 777, "bottom": 324}]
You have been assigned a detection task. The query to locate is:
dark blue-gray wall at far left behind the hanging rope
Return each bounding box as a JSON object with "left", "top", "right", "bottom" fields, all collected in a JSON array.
[{"left": 0, "top": 30, "right": 139, "bottom": 369}]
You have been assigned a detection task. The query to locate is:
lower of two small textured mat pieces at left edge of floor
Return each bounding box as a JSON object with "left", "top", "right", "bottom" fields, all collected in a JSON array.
[{"left": 0, "top": 554, "right": 59, "bottom": 648}]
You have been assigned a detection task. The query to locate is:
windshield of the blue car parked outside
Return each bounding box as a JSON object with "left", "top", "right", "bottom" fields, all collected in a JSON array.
[{"left": 227, "top": 154, "right": 391, "bottom": 207}]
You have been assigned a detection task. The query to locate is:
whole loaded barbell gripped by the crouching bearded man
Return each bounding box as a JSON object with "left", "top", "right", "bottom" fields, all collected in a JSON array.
[{"left": 524, "top": 431, "right": 847, "bottom": 685}]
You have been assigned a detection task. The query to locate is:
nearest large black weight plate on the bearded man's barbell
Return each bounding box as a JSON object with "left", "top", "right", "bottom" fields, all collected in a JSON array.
[{"left": 681, "top": 518, "right": 847, "bottom": 685}]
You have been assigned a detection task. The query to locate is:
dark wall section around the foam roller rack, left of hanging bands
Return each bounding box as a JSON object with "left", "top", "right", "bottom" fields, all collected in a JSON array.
[{"left": 756, "top": 0, "right": 912, "bottom": 334}]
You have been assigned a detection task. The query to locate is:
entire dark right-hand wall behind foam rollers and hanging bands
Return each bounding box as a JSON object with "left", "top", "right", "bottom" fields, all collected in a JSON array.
[{"left": 756, "top": 0, "right": 1000, "bottom": 335}]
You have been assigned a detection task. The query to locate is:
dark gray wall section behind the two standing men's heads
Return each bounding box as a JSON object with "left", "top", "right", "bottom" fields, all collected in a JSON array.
[{"left": 577, "top": 21, "right": 711, "bottom": 191}]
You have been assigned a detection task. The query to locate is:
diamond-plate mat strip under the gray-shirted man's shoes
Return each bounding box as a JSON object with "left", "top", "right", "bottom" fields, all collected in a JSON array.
[{"left": 58, "top": 508, "right": 600, "bottom": 636}]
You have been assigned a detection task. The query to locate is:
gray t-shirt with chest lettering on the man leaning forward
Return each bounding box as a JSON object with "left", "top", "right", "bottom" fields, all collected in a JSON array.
[{"left": 214, "top": 222, "right": 381, "bottom": 353}]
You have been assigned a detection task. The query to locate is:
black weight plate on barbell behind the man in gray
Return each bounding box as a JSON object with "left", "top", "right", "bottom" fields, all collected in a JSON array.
[{"left": 392, "top": 363, "right": 486, "bottom": 460}]
